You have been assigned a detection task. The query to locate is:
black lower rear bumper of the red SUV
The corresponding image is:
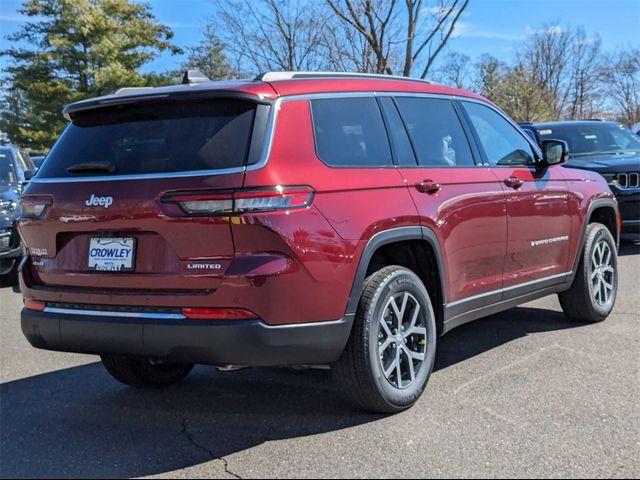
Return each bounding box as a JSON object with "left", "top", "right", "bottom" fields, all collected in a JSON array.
[{"left": 21, "top": 308, "right": 353, "bottom": 367}]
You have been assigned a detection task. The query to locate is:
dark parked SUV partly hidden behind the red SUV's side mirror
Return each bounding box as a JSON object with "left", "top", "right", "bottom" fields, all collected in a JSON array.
[{"left": 521, "top": 120, "right": 640, "bottom": 239}]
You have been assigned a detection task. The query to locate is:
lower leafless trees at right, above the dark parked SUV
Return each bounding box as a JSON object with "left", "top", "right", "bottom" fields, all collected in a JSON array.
[{"left": 434, "top": 23, "right": 640, "bottom": 125}]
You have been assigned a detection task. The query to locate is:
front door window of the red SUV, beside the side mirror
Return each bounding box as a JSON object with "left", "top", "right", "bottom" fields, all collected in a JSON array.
[{"left": 462, "top": 102, "right": 535, "bottom": 166}]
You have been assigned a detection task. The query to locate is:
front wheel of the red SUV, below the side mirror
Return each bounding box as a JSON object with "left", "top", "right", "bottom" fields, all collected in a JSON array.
[{"left": 558, "top": 223, "right": 618, "bottom": 323}]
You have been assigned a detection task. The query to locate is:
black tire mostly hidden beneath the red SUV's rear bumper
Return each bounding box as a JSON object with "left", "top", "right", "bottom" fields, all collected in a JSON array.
[{"left": 100, "top": 355, "right": 193, "bottom": 388}]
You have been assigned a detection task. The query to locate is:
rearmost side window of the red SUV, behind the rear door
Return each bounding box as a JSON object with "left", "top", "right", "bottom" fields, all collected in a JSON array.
[{"left": 311, "top": 98, "right": 393, "bottom": 167}]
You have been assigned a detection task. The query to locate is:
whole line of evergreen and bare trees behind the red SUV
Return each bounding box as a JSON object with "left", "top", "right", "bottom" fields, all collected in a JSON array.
[{"left": 0, "top": 0, "right": 640, "bottom": 151}]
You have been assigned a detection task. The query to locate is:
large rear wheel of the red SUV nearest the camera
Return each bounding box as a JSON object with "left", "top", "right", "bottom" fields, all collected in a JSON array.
[{"left": 331, "top": 266, "right": 437, "bottom": 413}]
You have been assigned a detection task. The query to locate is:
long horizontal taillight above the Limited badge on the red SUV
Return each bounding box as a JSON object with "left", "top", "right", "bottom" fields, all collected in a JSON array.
[{"left": 162, "top": 186, "right": 315, "bottom": 215}]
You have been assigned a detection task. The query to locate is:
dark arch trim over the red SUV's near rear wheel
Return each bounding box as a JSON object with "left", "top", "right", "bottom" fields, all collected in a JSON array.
[{"left": 345, "top": 226, "right": 447, "bottom": 315}]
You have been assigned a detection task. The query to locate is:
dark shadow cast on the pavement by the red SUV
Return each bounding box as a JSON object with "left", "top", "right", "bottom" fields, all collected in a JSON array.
[{"left": 0, "top": 308, "right": 576, "bottom": 478}]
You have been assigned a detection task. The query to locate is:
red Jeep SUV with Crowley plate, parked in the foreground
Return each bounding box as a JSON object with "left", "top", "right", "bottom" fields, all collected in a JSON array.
[{"left": 19, "top": 73, "right": 620, "bottom": 412}]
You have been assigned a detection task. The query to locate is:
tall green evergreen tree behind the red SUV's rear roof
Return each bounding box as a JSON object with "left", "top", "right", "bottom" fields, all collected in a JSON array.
[{"left": 0, "top": 0, "right": 179, "bottom": 151}]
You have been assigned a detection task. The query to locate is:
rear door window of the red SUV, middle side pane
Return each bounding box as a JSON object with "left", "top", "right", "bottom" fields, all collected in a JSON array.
[{"left": 396, "top": 97, "right": 475, "bottom": 167}]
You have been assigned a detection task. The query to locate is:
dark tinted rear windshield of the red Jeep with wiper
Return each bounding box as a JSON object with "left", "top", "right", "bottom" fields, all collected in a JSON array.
[{"left": 38, "top": 99, "right": 256, "bottom": 178}]
